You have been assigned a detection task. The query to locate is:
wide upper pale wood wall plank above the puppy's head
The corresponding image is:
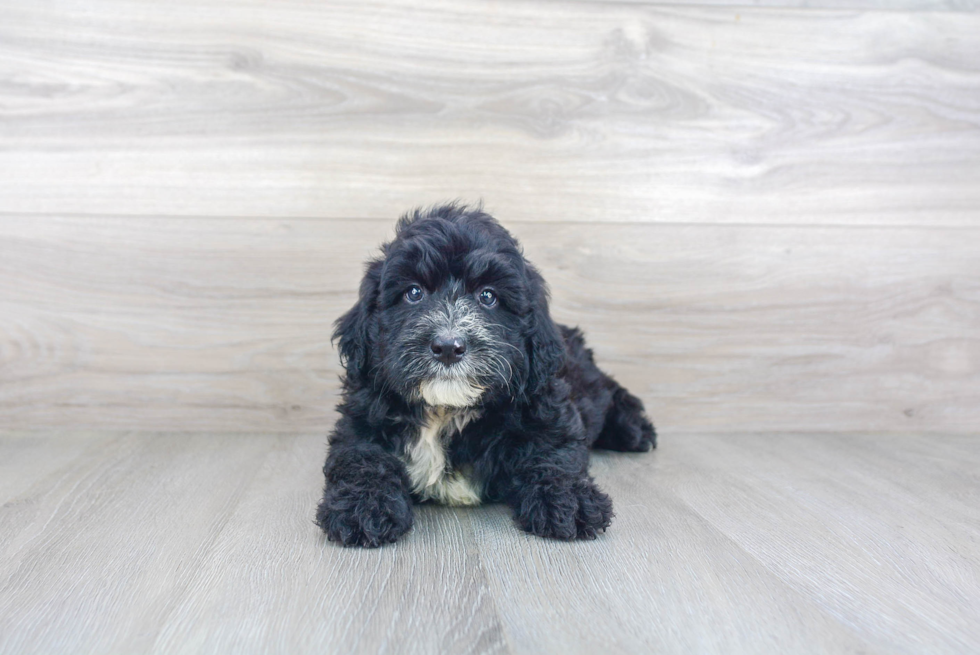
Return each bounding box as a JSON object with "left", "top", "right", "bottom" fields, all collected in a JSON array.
[{"left": 0, "top": 0, "right": 980, "bottom": 225}]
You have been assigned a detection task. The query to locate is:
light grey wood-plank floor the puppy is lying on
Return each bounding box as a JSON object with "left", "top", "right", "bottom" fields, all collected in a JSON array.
[{"left": 0, "top": 433, "right": 980, "bottom": 653}]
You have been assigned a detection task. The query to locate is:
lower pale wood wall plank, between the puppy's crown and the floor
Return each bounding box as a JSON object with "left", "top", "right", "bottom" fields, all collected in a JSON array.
[{"left": 0, "top": 216, "right": 980, "bottom": 431}]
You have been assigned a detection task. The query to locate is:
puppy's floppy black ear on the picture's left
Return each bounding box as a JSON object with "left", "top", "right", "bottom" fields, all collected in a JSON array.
[{"left": 332, "top": 259, "right": 383, "bottom": 381}]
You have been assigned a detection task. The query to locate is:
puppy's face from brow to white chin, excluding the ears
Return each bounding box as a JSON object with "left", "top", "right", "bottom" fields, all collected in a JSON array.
[{"left": 376, "top": 224, "right": 529, "bottom": 407}]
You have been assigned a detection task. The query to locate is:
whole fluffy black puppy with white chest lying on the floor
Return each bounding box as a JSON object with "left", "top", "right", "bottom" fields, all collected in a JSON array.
[{"left": 316, "top": 204, "right": 656, "bottom": 547}]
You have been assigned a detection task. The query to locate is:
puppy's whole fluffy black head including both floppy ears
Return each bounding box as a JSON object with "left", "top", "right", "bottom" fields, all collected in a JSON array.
[{"left": 335, "top": 207, "right": 564, "bottom": 407}]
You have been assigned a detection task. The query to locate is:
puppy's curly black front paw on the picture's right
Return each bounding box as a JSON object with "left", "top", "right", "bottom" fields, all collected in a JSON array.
[{"left": 514, "top": 478, "right": 613, "bottom": 540}]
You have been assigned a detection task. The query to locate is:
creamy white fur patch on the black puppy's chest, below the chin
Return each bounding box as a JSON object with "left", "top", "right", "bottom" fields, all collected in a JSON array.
[{"left": 405, "top": 407, "right": 481, "bottom": 505}]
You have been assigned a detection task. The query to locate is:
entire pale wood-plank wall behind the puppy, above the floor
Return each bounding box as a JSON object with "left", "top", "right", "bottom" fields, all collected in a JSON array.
[{"left": 0, "top": 0, "right": 980, "bottom": 432}]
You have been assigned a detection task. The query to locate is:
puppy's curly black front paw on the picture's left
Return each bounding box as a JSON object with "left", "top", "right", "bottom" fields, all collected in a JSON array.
[{"left": 316, "top": 483, "right": 412, "bottom": 548}]
